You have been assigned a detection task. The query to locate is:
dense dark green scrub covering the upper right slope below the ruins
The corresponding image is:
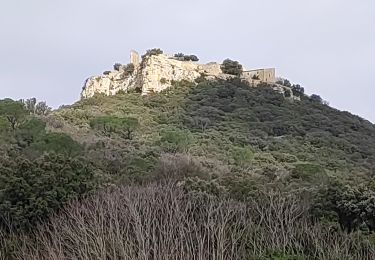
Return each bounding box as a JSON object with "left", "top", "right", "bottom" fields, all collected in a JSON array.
[{"left": 182, "top": 80, "right": 375, "bottom": 172}]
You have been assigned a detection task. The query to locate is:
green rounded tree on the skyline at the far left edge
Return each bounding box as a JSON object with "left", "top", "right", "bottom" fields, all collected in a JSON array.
[{"left": 0, "top": 99, "right": 28, "bottom": 131}]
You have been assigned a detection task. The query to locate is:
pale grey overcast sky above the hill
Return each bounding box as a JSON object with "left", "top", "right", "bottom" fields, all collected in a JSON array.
[{"left": 0, "top": 0, "right": 375, "bottom": 123}]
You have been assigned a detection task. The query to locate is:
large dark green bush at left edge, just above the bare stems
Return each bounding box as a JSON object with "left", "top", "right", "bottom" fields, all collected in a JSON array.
[{"left": 0, "top": 155, "right": 96, "bottom": 229}]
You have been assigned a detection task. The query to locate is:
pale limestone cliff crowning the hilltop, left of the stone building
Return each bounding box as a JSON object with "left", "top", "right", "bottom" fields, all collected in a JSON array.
[{"left": 81, "top": 52, "right": 225, "bottom": 98}]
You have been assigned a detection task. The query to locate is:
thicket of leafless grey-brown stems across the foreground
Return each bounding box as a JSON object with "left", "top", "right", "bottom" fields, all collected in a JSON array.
[{"left": 2, "top": 184, "right": 375, "bottom": 260}]
